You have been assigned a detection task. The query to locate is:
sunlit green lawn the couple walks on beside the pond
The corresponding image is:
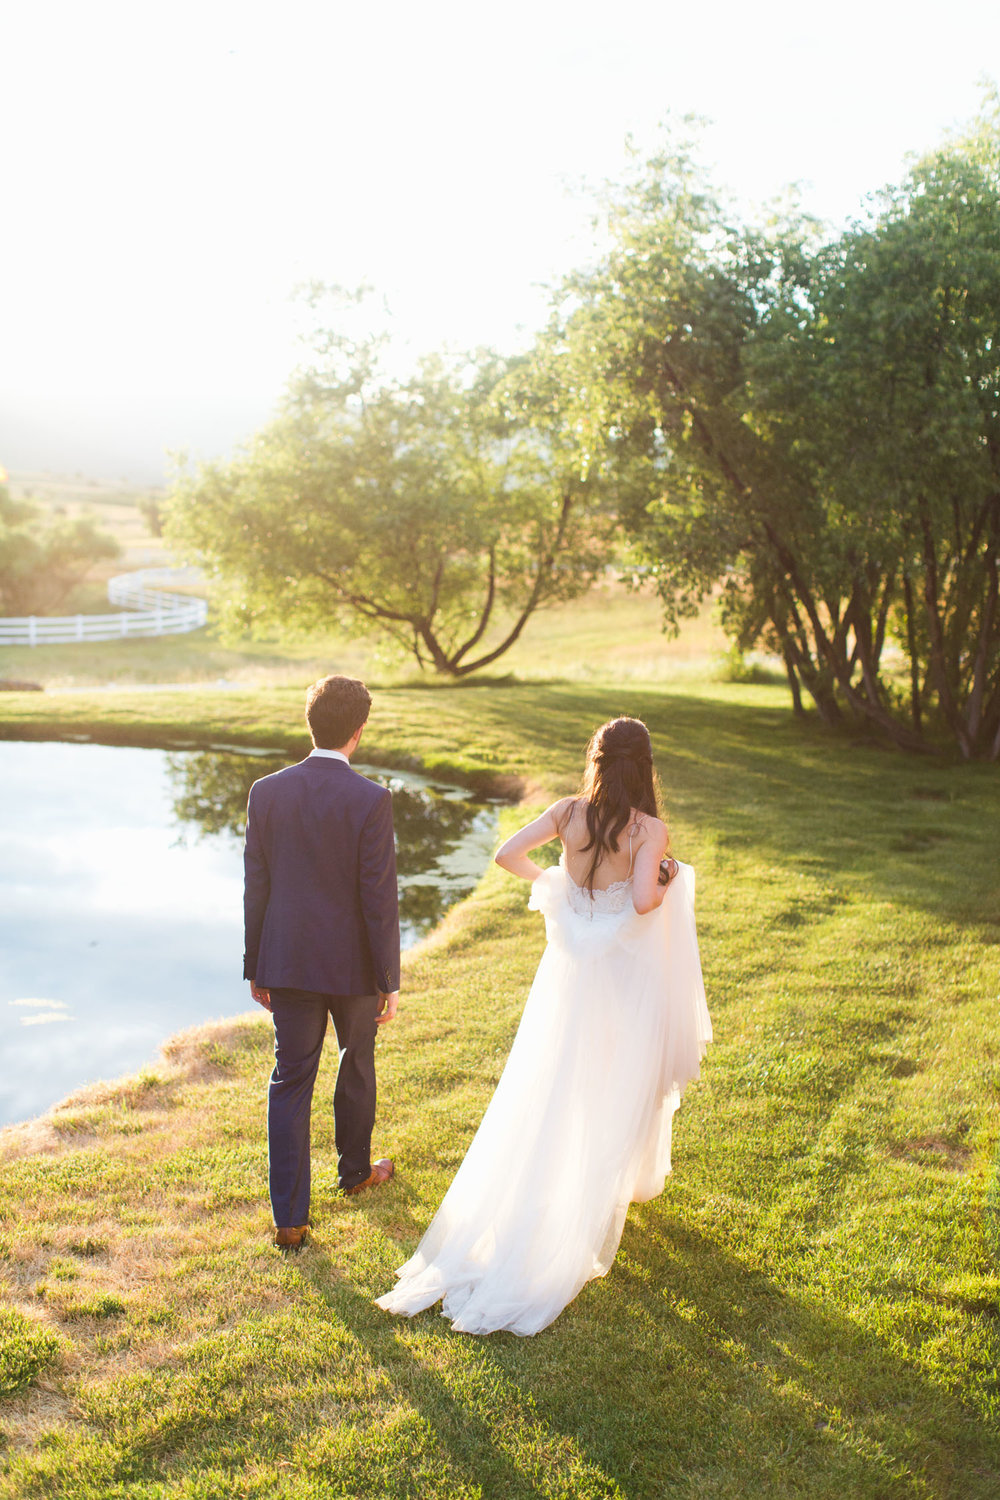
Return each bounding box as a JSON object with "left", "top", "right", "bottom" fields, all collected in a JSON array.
[{"left": 0, "top": 632, "right": 1000, "bottom": 1500}]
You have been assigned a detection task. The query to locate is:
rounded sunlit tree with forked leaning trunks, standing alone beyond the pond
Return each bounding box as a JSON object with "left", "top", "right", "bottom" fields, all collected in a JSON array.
[{"left": 166, "top": 336, "right": 606, "bottom": 677}]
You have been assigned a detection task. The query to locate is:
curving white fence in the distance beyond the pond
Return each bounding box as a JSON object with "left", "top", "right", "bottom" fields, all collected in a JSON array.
[{"left": 0, "top": 567, "right": 208, "bottom": 647}]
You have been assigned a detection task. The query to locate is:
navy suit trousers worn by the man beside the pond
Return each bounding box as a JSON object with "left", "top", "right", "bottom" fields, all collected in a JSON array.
[{"left": 267, "top": 989, "right": 378, "bottom": 1229}]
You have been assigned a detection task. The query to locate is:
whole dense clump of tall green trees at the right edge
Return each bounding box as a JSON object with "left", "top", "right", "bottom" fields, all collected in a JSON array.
[{"left": 556, "top": 111, "right": 1000, "bottom": 759}]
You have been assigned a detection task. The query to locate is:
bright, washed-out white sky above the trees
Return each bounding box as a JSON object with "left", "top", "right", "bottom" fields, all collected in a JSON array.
[{"left": 0, "top": 0, "right": 1000, "bottom": 479}]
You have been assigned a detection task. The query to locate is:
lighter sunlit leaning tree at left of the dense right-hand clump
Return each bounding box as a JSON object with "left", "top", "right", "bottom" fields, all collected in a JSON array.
[{"left": 550, "top": 141, "right": 840, "bottom": 719}]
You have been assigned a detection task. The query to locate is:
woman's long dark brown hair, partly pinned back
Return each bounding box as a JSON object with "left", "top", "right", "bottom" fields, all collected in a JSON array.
[{"left": 569, "top": 719, "right": 660, "bottom": 891}]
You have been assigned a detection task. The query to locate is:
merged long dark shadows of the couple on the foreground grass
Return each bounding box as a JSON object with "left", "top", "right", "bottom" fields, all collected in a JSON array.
[{"left": 301, "top": 1206, "right": 1000, "bottom": 1500}]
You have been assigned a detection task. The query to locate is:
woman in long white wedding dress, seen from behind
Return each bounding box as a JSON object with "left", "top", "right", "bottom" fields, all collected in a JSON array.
[{"left": 378, "top": 719, "right": 712, "bottom": 1334}]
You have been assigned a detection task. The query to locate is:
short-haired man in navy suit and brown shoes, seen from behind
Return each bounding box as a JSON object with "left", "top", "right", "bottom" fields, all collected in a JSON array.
[{"left": 243, "top": 677, "right": 399, "bottom": 1250}]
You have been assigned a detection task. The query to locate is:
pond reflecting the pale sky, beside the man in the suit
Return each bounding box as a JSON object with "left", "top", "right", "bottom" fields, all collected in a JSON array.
[{"left": 0, "top": 741, "right": 498, "bottom": 1125}]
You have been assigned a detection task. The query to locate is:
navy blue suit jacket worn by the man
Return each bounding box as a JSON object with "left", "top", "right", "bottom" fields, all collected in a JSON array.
[{"left": 243, "top": 756, "right": 399, "bottom": 995}]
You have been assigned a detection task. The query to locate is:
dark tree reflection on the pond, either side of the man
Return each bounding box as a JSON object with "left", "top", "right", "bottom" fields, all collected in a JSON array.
[{"left": 166, "top": 750, "right": 496, "bottom": 948}]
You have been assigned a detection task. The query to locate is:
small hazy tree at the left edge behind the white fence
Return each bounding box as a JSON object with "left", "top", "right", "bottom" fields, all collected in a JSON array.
[{"left": 0, "top": 485, "right": 120, "bottom": 615}]
